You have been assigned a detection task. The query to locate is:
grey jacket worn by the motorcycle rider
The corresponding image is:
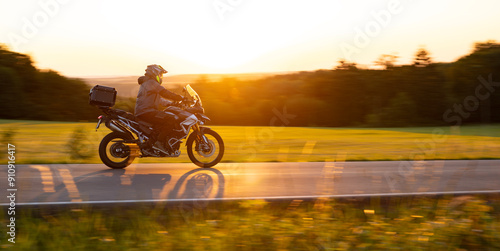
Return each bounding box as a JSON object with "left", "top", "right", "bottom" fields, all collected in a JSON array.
[{"left": 135, "top": 77, "right": 182, "bottom": 116}]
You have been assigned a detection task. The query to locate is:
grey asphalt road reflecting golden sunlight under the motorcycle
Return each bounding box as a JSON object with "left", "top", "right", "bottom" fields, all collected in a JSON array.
[{"left": 0, "top": 160, "right": 500, "bottom": 206}]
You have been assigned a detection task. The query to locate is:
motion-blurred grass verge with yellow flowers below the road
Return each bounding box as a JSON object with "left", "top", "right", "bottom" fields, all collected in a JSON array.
[{"left": 1, "top": 195, "right": 500, "bottom": 250}]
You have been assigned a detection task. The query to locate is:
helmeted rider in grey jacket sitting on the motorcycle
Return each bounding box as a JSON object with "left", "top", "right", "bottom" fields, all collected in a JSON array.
[{"left": 135, "top": 64, "right": 186, "bottom": 152}]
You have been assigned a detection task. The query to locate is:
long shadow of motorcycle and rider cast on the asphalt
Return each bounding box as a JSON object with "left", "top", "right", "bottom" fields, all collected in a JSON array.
[{"left": 32, "top": 168, "right": 225, "bottom": 202}]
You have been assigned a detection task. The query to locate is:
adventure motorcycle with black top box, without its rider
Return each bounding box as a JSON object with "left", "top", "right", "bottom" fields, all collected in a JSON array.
[{"left": 89, "top": 85, "right": 224, "bottom": 169}]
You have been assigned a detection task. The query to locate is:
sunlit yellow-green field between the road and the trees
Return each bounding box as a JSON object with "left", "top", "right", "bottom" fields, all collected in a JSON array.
[{"left": 0, "top": 120, "right": 500, "bottom": 164}]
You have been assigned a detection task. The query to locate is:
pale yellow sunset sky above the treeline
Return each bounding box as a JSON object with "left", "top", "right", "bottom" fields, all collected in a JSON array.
[{"left": 0, "top": 0, "right": 500, "bottom": 77}]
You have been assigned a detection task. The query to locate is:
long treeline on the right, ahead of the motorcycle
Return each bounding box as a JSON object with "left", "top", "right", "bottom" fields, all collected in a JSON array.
[{"left": 193, "top": 41, "right": 500, "bottom": 127}]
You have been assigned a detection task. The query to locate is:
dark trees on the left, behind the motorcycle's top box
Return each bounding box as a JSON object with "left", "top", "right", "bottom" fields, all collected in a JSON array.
[{"left": 0, "top": 45, "right": 97, "bottom": 121}]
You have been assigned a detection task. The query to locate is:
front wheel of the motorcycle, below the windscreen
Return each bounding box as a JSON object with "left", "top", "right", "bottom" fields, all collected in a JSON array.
[{"left": 186, "top": 129, "right": 224, "bottom": 168}]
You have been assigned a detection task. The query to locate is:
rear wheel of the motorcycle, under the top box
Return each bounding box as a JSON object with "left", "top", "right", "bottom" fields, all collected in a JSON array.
[{"left": 99, "top": 132, "right": 135, "bottom": 169}]
